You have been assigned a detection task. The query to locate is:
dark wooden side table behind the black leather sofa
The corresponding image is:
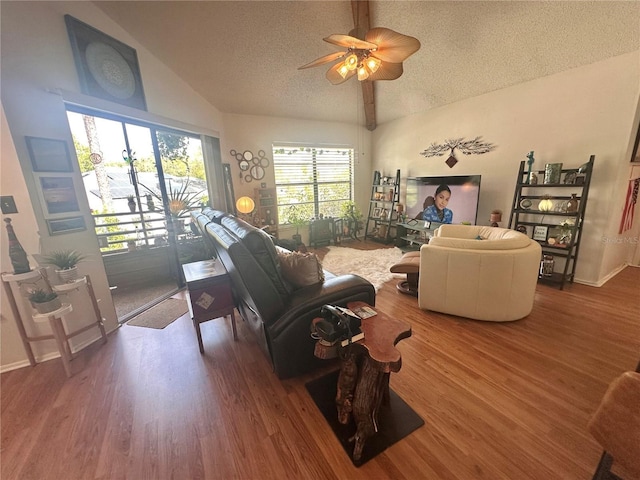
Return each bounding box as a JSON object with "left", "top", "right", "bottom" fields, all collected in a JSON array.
[{"left": 182, "top": 260, "right": 238, "bottom": 353}]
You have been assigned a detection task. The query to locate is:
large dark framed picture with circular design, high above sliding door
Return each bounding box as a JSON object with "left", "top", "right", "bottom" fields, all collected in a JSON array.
[{"left": 64, "top": 15, "right": 147, "bottom": 110}]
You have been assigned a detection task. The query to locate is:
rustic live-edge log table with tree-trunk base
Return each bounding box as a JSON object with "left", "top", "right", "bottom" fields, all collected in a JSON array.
[{"left": 315, "top": 302, "right": 411, "bottom": 462}]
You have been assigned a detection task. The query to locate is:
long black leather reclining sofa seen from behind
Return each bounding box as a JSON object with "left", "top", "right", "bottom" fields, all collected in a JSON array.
[{"left": 192, "top": 208, "right": 376, "bottom": 379}]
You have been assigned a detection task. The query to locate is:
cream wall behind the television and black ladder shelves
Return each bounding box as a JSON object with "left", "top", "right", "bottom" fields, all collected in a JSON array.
[{"left": 372, "top": 52, "right": 640, "bottom": 285}]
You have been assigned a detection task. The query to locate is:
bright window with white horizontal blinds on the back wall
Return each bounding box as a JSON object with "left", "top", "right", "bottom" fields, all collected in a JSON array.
[{"left": 273, "top": 145, "right": 354, "bottom": 224}]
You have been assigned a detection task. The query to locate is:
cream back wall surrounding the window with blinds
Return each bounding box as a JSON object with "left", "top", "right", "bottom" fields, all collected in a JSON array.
[{"left": 221, "top": 114, "right": 373, "bottom": 242}]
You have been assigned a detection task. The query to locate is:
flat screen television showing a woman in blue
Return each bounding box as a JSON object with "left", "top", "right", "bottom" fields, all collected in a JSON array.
[{"left": 405, "top": 175, "right": 480, "bottom": 225}]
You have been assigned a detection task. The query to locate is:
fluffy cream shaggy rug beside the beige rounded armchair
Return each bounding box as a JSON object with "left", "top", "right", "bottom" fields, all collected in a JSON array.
[{"left": 322, "top": 247, "right": 405, "bottom": 291}]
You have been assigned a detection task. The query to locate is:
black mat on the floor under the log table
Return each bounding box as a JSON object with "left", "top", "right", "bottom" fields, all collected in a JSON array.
[{"left": 305, "top": 370, "right": 424, "bottom": 467}]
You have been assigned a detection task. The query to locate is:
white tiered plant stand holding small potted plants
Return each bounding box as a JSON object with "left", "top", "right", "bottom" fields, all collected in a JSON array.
[{"left": 2, "top": 269, "right": 107, "bottom": 377}]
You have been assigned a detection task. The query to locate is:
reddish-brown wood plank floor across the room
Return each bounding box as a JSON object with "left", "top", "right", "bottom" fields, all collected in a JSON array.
[{"left": 0, "top": 242, "right": 640, "bottom": 480}]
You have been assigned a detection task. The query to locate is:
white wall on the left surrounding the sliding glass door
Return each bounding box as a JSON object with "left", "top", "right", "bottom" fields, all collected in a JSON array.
[{"left": 0, "top": 2, "right": 222, "bottom": 370}]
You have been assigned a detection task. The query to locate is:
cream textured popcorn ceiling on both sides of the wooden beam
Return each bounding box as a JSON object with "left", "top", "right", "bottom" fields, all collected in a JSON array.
[{"left": 95, "top": 1, "right": 640, "bottom": 125}]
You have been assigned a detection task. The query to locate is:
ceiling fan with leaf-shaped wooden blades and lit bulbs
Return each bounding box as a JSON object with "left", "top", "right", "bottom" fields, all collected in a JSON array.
[{"left": 298, "top": 27, "right": 420, "bottom": 85}]
